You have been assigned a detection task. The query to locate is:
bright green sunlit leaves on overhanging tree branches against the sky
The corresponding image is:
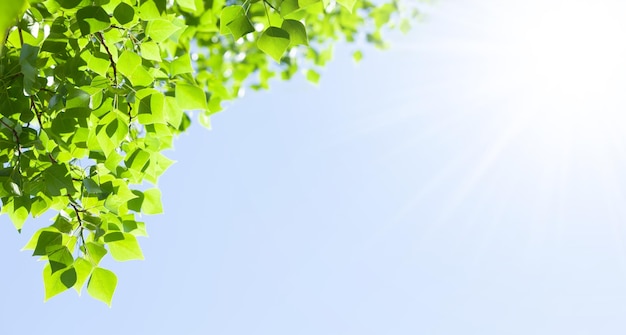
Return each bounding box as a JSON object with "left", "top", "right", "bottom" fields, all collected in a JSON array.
[{"left": 0, "top": 0, "right": 417, "bottom": 305}]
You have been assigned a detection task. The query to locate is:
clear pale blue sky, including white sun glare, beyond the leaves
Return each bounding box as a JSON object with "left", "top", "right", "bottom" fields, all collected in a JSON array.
[{"left": 0, "top": 0, "right": 626, "bottom": 335}]
